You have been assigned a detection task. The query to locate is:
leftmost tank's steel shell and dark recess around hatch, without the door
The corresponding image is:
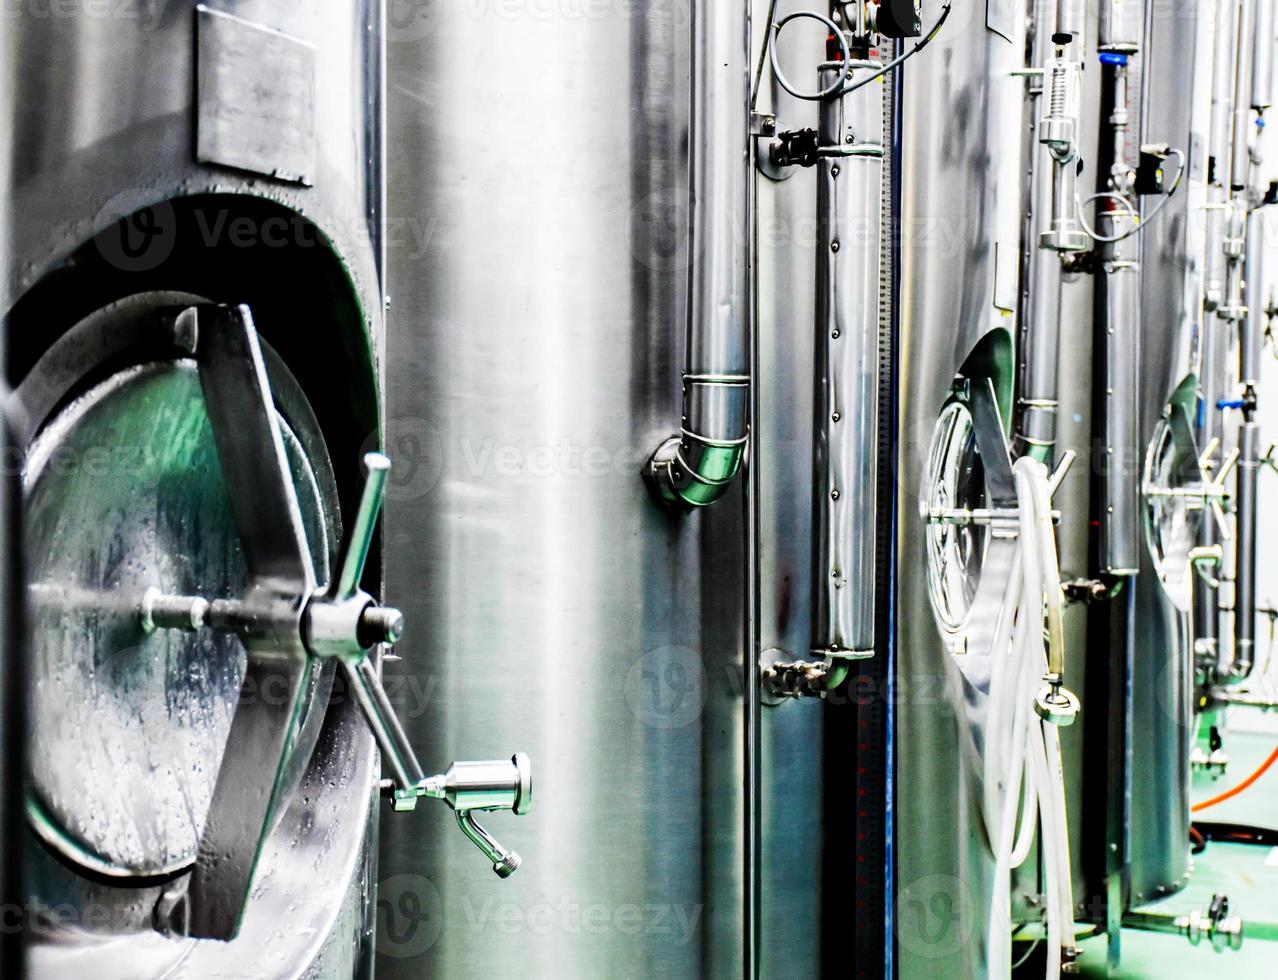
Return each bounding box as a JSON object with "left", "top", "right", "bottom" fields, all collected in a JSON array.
[{"left": 3, "top": 0, "right": 383, "bottom": 976}]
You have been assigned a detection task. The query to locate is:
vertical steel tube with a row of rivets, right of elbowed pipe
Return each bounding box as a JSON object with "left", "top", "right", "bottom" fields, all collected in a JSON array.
[{"left": 812, "top": 61, "right": 883, "bottom": 658}]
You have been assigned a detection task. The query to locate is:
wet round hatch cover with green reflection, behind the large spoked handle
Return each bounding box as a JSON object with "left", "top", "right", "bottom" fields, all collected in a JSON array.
[{"left": 19, "top": 301, "right": 340, "bottom": 877}]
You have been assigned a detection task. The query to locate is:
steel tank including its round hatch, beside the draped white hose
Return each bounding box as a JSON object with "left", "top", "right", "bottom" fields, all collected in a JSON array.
[{"left": 893, "top": 4, "right": 1025, "bottom": 976}]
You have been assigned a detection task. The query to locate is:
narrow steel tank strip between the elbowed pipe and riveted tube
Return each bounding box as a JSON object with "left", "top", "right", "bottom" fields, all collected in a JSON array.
[{"left": 750, "top": 0, "right": 829, "bottom": 977}]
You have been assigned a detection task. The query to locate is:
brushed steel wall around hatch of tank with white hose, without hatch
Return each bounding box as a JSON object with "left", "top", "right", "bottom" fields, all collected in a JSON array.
[{"left": 893, "top": 4, "right": 1025, "bottom": 977}]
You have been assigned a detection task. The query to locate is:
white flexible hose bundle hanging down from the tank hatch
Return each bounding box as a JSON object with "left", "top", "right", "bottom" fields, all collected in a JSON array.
[{"left": 984, "top": 457, "right": 1074, "bottom": 980}]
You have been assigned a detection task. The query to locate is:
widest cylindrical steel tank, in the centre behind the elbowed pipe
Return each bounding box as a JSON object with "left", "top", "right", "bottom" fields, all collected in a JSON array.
[{"left": 378, "top": 0, "right": 754, "bottom": 977}]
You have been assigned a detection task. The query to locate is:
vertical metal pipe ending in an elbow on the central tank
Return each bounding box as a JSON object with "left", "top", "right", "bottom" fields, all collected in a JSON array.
[{"left": 647, "top": 0, "right": 750, "bottom": 507}]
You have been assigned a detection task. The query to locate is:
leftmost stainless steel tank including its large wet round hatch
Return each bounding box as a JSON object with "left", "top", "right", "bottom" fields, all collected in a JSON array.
[{"left": 4, "top": 0, "right": 388, "bottom": 977}]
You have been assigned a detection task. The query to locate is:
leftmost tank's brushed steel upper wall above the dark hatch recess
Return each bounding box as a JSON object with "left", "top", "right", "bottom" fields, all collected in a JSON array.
[{"left": 5, "top": 0, "right": 383, "bottom": 341}]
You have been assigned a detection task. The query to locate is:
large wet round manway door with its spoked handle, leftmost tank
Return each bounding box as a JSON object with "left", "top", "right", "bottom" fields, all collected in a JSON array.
[{"left": 19, "top": 301, "right": 532, "bottom": 939}]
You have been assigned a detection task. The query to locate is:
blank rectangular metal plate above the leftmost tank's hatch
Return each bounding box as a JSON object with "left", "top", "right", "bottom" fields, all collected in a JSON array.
[{"left": 196, "top": 6, "right": 316, "bottom": 185}]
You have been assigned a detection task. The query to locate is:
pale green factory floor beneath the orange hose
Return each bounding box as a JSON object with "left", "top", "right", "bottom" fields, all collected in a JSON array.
[{"left": 1081, "top": 709, "right": 1278, "bottom": 980}]
